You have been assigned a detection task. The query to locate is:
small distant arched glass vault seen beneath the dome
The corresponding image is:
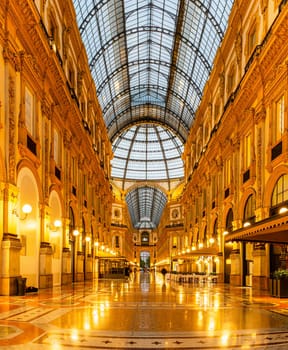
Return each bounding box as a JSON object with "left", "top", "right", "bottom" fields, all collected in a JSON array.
[{"left": 126, "top": 186, "right": 167, "bottom": 229}]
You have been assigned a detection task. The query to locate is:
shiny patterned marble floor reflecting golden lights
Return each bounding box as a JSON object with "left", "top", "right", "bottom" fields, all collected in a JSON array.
[{"left": 0, "top": 273, "right": 288, "bottom": 350}]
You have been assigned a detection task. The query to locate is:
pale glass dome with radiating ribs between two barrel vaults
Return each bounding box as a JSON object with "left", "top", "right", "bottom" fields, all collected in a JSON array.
[{"left": 112, "top": 124, "right": 184, "bottom": 183}]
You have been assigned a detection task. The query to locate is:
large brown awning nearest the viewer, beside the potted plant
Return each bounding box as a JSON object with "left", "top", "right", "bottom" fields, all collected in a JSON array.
[{"left": 225, "top": 215, "right": 288, "bottom": 244}]
